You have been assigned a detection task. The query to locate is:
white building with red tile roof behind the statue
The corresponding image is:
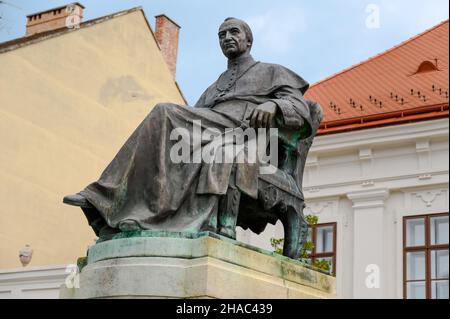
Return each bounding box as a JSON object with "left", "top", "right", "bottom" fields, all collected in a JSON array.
[{"left": 240, "top": 21, "right": 449, "bottom": 298}]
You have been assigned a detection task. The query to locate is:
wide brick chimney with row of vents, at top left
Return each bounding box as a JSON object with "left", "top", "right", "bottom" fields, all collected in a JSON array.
[{"left": 26, "top": 2, "right": 84, "bottom": 36}]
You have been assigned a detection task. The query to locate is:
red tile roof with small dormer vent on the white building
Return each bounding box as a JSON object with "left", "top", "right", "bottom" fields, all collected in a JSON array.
[{"left": 306, "top": 20, "right": 449, "bottom": 134}]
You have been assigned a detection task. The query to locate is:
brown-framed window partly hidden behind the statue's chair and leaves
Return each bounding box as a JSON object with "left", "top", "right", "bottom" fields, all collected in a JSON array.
[{"left": 308, "top": 223, "right": 336, "bottom": 274}]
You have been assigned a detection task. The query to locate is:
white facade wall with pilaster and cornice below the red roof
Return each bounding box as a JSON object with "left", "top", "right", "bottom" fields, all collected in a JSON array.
[{"left": 238, "top": 119, "right": 449, "bottom": 298}]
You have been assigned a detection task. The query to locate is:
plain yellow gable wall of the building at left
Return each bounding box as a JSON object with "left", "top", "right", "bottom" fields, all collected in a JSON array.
[{"left": 0, "top": 10, "right": 184, "bottom": 268}]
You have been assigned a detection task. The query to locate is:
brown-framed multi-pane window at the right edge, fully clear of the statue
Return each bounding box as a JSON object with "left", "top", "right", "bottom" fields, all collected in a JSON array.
[{"left": 403, "top": 213, "right": 449, "bottom": 299}]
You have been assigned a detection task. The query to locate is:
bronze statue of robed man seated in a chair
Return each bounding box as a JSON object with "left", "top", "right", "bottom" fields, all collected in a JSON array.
[{"left": 63, "top": 18, "right": 322, "bottom": 258}]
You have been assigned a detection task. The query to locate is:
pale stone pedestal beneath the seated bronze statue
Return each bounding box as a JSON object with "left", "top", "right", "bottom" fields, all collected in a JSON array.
[{"left": 60, "top": 231, "right": 336, "bottom": 299}]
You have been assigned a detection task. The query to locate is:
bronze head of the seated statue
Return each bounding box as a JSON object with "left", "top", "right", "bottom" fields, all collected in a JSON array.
[{"left": 218, "top": 18, "right": 253, "bottom": 59}]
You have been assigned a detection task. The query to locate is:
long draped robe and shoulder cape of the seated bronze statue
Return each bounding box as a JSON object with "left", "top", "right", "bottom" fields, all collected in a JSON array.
[{"left": 80, "top": 56, "right": 311, "bottom": 235}]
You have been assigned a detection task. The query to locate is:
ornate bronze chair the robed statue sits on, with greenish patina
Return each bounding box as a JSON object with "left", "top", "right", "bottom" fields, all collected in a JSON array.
[{"left": 219, "top": 101, "right": 322, "bottom": 259}]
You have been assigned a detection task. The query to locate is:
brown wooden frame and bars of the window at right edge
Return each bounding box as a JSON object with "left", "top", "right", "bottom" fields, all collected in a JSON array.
[{"left": 403, "top": 213, "right": 449, "bottom": 299}]
